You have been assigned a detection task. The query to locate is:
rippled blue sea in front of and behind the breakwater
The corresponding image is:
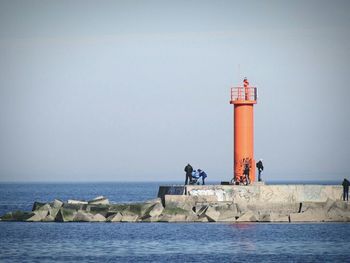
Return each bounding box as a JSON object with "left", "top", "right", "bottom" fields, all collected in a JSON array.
[{"left": 0, "top": 182, "right": 350, "bottom": 263}]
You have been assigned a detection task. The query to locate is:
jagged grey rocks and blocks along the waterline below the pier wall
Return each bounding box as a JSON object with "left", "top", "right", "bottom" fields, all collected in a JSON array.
[{"left": 1, "top": 195, "right": 350, "bottom": 223}]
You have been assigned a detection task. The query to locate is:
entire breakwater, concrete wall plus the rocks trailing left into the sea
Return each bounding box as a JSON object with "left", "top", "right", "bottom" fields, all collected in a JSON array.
[{"left": 1, "top": 184, "right": 350, "bottom": 222}]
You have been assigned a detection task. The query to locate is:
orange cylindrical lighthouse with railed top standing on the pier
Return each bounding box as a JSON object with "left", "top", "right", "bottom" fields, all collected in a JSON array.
[{"left": 230, "top": 78, "right": 257, "bottom": 183}]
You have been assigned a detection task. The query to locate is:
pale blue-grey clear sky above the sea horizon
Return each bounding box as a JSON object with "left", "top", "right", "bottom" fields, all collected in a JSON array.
[{"left": 0, "top": 0, "right": 350, "bottom": 182}]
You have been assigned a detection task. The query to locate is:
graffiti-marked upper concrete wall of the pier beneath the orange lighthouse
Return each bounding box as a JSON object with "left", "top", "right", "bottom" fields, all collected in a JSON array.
[{"left": 158, "top": 184, "right": 342, "bottom": 204}]
